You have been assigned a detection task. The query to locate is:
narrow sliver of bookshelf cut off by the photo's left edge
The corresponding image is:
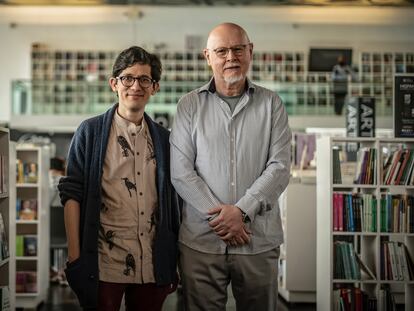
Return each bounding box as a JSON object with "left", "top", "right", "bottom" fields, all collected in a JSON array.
[{"left": 0, "top": 128, "right": 13, "bottom": 310}]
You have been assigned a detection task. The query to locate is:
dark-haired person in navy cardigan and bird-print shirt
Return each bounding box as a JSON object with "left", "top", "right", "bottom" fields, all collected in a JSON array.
[{"left": 59, "top": 46, "right": 180, "bottom": 311}]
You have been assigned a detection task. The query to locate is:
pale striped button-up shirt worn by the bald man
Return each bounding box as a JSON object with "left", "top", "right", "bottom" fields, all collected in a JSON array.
[{"left": 170, "top": 79, "right": 291, "bottom": 254}]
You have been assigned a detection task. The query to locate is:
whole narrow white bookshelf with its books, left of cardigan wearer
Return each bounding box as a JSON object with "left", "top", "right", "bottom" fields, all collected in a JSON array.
[{"left": 12, "top": 145, "right": 50, "bottom": 308}]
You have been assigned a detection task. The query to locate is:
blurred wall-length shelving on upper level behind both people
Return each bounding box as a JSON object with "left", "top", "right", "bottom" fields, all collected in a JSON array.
[{"left": 8, "top": 43, "right": 414, "bottom": 127}]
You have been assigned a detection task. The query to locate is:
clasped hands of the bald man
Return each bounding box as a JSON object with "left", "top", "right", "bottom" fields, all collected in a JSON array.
[{"left": 208, "top": 205, "right": 251, "bottom": 246}]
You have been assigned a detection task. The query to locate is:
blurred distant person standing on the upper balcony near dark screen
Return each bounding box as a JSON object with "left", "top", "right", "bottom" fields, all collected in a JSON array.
[{"left": 332, "top": 55, "right": 355, "bottom": 115}]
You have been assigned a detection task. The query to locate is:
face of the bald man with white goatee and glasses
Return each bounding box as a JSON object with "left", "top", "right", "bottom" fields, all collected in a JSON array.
[{"left": 204, "top": 27, "right": 253, "bottom": 87}]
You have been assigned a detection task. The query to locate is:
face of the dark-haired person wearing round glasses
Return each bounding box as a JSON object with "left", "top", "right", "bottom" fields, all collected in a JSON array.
[{"left": 109, "top": 63, "right": 159, "bottom": 112}]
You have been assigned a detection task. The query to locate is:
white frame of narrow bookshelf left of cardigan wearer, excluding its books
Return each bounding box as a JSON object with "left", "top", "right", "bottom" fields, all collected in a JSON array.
[{"left": 11, "top": 145, "right": 50, "bottom": 308}]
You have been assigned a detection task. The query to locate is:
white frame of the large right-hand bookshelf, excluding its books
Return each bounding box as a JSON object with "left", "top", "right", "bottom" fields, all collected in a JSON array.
[{"left": 316, "top": 137, "right": 414, "bottom": 311}]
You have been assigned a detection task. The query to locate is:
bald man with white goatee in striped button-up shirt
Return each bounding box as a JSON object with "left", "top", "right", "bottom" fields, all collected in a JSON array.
[{"left": 170, "top": 23, "right": 291, "bottom": 311}]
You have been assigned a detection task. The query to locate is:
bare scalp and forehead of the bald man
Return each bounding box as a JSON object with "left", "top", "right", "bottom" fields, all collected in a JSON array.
[{"left": 207, "top": 23, "right": 250, "bottom": 49}]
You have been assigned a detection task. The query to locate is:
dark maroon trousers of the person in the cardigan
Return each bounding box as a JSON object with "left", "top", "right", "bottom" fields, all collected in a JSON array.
[{"left": 86, "top": 281, "right": 174, "bottom": 311}]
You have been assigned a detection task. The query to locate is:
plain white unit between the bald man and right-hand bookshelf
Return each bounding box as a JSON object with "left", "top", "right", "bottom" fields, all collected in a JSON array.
[{"left": 278, "top": 175, "right": 316, "bottom": 303}]
